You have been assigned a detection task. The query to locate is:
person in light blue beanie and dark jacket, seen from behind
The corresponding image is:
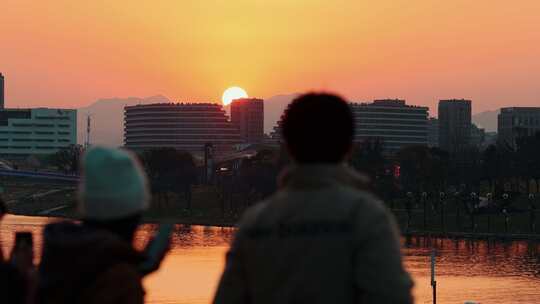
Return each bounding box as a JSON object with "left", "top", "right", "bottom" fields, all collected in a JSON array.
[{"left": 37, "top": 147, "right": 150, "bottom": 304}]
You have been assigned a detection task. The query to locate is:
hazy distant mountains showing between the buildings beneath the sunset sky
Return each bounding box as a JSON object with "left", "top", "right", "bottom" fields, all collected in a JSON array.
[{"left": 77, "top": 94, "right": 298, "bottom": 146}]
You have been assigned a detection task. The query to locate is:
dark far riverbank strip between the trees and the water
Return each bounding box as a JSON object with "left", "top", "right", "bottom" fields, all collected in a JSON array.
[{"left": 7, "top": 187, "right": 540, "bottom": 240}]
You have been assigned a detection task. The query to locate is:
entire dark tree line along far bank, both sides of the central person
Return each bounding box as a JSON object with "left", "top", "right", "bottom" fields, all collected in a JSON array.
[{"left": 47, "top": 133, "right": 540, "bottom": 216}]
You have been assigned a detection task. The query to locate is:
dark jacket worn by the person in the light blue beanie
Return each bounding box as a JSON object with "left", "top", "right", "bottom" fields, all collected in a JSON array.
[{"left": 37, "top": 222, "right": 144, "bottom": 304}]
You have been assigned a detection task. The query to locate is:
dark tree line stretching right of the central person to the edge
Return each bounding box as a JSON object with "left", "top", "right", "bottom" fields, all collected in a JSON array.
[{"left": 351, "top": 132, "right": 540, "bottom": 203}]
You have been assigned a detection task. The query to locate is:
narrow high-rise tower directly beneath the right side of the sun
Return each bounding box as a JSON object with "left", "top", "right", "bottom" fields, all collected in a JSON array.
[{"left": 231, "top": 98, "right": 264, "bottom": 144}]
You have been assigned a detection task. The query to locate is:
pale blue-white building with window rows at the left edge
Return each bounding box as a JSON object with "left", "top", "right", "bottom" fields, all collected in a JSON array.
[{"left": 0, "top": 108, "right": 77, "bottom": 157}]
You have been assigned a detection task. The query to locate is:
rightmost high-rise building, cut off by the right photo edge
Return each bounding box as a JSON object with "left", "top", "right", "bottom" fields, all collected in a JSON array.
[{"left": 497, "top": 107, "right": 540, "bottom": 149}]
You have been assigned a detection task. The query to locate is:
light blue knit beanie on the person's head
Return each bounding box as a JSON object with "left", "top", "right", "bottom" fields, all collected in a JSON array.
[{"left": 79, "top": 147, "right": 150, "bottom": 220}]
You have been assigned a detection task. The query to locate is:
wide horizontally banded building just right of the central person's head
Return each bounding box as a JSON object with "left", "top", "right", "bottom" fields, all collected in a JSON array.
[{"left": 351, "top": 99, "right": 429, "bottom": 153}]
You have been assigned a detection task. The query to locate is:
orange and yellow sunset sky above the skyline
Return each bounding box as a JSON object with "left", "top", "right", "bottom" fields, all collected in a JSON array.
[{"left": 0, "top": 0, "right": 540, "bottom": 113}]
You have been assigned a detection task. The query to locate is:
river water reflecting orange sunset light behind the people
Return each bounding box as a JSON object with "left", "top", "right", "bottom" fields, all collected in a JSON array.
[{"left": 0, "top": 216, "right": 540, "bottom": 304}]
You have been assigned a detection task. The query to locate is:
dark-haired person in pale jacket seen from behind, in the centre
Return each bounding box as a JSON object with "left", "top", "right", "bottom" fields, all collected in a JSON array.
[{"left": 214, "top": 93, "right": 412, "bottom": 304}]
